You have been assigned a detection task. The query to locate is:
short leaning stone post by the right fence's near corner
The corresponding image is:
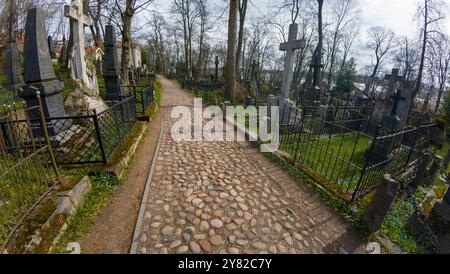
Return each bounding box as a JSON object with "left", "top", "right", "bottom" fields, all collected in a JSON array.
[{"left": 363, "top": 174, "right": 398, "bottom": 231}]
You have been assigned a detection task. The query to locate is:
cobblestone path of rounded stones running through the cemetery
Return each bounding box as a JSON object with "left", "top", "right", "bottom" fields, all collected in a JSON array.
[{"left": 131, "top": 79, "right": 365, "bottom": 254}]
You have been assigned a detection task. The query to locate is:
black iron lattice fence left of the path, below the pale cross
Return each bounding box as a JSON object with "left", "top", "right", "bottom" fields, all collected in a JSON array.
[{"left": 0, "top": 88, "right": 154, "bottom": 165}]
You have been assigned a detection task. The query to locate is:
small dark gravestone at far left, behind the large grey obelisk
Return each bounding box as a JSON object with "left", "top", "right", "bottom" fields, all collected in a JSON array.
[{"left": 6, "top": 43, "right": 24, "bottom": 90}]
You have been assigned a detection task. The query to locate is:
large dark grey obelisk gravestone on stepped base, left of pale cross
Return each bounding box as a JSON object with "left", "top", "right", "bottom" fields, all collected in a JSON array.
[{"left": 20, "top": 8, "right": 66, "bottom": 136}]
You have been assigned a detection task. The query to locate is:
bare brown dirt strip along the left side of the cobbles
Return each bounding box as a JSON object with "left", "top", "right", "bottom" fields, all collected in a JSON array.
[{"left": 79, "top": 91, "right": 165, "bottom": 254}]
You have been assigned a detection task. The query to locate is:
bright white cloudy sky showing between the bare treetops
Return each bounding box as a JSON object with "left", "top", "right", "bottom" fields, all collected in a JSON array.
[{"left": 149, "top": 0, "right": 450, "bottom": 67}]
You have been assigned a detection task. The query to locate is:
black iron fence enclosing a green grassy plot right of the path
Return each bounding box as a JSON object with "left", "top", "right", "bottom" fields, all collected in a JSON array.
[{"left": 280, "top": 103, "right": 436, "bottom": 201}]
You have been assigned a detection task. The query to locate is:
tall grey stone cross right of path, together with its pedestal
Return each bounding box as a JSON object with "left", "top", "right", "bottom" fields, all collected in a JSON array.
[{"left": 280, "top": 23, "right": 306, "bottom": 124}]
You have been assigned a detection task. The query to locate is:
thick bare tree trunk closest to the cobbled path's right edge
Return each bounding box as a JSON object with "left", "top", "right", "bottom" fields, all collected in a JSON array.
[{"left": 225, "top": 0, "right": 239, "bottom": 103}]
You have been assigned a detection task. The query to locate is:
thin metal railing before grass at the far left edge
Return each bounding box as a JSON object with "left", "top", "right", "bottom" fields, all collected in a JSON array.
[{"left": 0, "top": 98, "right": 59, "bottom": 245}]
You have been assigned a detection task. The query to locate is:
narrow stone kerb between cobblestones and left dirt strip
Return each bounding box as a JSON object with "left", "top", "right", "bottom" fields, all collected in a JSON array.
[{"left": 130, "top": 122, "right": 165, "bottom": 254}]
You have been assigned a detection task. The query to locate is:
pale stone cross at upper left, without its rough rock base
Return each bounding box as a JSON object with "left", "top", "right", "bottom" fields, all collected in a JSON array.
[{"left": 64, "top": 0, "right": 98, "bottom": 90}]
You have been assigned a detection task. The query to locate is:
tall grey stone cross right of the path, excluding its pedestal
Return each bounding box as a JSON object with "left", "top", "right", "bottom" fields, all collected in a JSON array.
[{"left": 280, "top": 23, "right": 306, "bottom": 101}]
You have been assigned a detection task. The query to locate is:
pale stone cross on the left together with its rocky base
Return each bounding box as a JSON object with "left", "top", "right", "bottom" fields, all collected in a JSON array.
[{"left": 64, "top": 0, "right": 108, "bottom": 116}]
